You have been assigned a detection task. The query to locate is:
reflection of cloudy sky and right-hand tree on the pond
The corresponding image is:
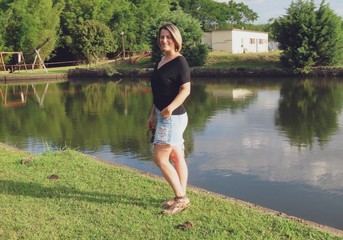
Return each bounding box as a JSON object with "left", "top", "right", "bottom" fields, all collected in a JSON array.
[{"left": 194, "top": 80, "right": 343, "bottom": 191}]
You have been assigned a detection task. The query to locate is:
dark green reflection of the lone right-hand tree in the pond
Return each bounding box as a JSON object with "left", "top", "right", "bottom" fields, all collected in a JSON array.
[{"left": 275, "top": 80, "right": 343, "bottom": 149}]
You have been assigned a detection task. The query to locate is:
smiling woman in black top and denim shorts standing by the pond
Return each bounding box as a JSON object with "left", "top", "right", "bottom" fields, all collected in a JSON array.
[{"left": 147, "top": 23, "right": 191, "bottom": 214}]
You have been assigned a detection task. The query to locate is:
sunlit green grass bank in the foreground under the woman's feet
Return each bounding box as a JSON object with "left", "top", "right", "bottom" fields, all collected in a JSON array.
[{"left": 0, "top": 145, "right": 341, "bottom": 240}]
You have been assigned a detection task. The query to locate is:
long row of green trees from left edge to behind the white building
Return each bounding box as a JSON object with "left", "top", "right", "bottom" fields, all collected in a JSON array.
[{"left": 0, "top": 0, "right": 258, "bottom": 65}]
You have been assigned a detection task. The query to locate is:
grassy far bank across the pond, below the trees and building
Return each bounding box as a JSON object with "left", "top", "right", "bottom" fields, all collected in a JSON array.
[{"left": 0, "top": 51, "right": 342, "bottom": 79}]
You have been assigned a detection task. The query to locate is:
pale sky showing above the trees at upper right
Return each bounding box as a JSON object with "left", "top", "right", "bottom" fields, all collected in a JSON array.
[{"left": 216, "top": 0, "right": 343, "bottom": 24}]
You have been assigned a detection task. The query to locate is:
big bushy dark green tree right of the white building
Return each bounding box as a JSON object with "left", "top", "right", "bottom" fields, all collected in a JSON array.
[{"left": 272, "top": 0, "right": 343, "bottom": 73}]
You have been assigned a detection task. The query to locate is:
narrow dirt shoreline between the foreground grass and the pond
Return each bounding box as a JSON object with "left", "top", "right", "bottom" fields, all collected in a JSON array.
[{"left": 0, "top": 142, "right": 343, "bottom": 237}]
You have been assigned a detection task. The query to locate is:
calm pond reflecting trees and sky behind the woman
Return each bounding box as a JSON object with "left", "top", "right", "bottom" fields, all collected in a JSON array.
[{"left": 0, "top": 79, "right": 343, "bottom": 230}]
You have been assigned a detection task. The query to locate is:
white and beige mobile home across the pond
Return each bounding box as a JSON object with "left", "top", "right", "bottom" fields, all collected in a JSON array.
[{"left": 202, "top": 29, "right": 268, "bottom": 53}]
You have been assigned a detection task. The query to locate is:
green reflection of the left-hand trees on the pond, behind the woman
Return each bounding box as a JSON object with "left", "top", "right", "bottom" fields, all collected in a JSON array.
[{"left": 0, "top": 80, "right": 256, "bottom": 160}]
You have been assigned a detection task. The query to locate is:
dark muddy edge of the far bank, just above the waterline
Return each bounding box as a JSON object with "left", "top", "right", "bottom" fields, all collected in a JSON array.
[{"left": 68, "top": 67, "right": 343, "bottom": 78}]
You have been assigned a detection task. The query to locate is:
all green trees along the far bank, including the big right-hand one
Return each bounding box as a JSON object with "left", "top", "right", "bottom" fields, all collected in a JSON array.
[{"left": 0, "top": 0, "right": 343, "bottom": 72}]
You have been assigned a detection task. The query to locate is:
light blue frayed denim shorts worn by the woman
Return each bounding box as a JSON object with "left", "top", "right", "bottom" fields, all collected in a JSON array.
[{"left": 154, "top": 108, "right": 188, "bottom": 147}]
